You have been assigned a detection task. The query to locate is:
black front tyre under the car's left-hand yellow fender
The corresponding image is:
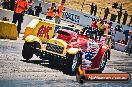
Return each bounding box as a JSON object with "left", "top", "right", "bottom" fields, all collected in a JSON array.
[{"left": 22, "top": 42, "right": 33, "bottom": 60}]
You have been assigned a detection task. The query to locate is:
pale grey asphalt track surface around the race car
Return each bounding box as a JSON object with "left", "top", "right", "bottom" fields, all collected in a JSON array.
[{"left": 0, "top": 38, "right": 132, "bottom": 87}]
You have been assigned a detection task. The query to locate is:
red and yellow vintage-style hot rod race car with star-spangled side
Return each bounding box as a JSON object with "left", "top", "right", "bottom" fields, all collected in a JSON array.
[{"left": 22, "top": 29, "right": 110, "bottom": 73}]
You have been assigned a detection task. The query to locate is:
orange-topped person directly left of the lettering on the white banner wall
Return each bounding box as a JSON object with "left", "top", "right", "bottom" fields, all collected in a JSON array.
[{"left": 55, "top": 3, "right": 65, "bottom": 24}]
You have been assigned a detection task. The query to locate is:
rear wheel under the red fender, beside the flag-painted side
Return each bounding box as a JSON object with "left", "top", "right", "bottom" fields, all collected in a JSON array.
[{"left": 97, "top": 51, "right": 109, "bottom": 73}]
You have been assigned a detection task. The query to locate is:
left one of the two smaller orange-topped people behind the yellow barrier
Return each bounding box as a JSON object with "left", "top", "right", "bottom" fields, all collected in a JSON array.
[{"left": 46, "top": 3, "right": 56, "bottom": 20}]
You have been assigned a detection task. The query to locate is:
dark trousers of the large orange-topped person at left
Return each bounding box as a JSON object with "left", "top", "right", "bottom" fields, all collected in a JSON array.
[{"left": 12, "top": 12, "right": 24, "bottom": 35}]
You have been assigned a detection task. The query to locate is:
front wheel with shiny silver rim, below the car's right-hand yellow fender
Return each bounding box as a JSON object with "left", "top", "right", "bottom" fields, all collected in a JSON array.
[{"left": 66, "top": 52, "right": 82, "bottom": 74}]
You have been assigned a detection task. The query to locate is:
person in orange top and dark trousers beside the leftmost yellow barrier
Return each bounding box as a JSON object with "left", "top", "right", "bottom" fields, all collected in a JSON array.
[{"left": 12, "top": 0, "right": 29, "bottom": 37}]
